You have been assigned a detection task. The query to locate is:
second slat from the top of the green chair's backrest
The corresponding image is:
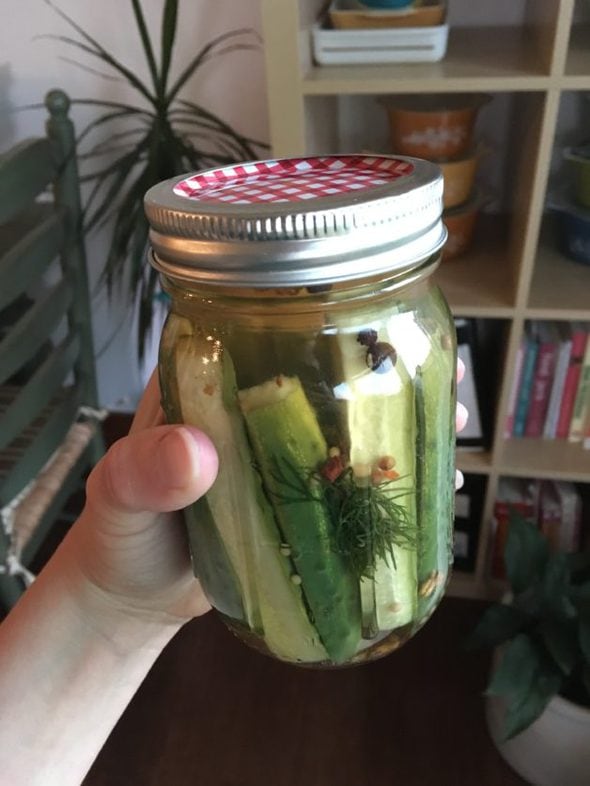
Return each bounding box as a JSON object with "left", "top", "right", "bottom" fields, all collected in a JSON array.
[{"left": 0, "top": 209, "right": 64, "bottom": 310}]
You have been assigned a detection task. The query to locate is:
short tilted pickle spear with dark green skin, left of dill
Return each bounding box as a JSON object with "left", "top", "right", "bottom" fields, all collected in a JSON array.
[{"left": 238, "top": 376, "right": 361, "bottom": 663}]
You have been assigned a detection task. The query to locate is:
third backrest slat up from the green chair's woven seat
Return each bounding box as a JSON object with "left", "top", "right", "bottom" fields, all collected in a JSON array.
[{"left": 0, "top": 281, "right": 72, "bottom": 385}]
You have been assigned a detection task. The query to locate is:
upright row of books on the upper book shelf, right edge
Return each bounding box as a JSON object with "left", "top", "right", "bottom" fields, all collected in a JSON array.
[{"left": 504, "top": 321, "right": 590, "bottom": 440}]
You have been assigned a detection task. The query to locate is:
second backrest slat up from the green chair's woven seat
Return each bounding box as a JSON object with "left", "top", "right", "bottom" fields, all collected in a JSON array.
[{"left": 0, "top": 334, "right": 80, "bottom": 450}]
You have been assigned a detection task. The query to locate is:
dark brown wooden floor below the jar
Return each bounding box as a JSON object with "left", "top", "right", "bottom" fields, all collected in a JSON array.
[{"left": 84, "top": 599, "right": 524, "bottom": 786}]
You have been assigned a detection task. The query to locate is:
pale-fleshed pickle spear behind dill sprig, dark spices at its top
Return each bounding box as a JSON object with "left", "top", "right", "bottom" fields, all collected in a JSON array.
[{"left": 338, "top": 330, "right": 417, "bottom": 638}]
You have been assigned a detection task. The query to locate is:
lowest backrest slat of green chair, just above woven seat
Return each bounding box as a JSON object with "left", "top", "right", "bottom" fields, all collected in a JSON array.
[{"left": 0, "top": 388, "right": 82, "bottom": 506}]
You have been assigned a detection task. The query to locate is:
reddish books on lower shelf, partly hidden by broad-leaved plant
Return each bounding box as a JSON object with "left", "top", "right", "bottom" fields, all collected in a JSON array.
[{"left": 490, "top": 478, "right": 582, "bottom": 578}]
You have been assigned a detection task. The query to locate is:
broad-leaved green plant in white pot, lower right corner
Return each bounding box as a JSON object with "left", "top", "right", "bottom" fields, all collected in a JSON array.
[{"left": 470, "top": 514, "right": 590, "bottom": 786}]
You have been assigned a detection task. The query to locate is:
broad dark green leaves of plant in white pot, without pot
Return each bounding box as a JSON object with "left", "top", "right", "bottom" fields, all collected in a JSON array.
[{"left": 470, "top": 513, "right": 590, "bottom": 739}]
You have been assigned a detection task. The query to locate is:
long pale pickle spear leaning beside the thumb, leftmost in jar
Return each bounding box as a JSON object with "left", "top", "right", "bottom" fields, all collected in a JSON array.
[{"left": 169, "top": 324, "right": 327, "bottom": 662}]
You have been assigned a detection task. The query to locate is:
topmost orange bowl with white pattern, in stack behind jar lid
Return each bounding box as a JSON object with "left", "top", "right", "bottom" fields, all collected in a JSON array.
[{"left": 385, "top": 93, "right": 489, "bottom": 159}]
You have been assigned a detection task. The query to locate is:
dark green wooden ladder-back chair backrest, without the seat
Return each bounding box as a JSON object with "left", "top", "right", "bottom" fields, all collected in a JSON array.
[{"left": 0, "top": 90, "right": 97, "bottom": 507}]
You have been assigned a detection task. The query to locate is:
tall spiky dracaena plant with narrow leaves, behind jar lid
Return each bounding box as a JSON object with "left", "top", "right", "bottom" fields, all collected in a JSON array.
[{"left": 45, "top": 0, "right": 267, "bottom": 357}]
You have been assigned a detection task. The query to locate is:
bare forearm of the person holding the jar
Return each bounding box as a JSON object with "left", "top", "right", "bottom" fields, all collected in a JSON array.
[{"left": 0, "top": 546, "right": 180, "bottom": 786}]
